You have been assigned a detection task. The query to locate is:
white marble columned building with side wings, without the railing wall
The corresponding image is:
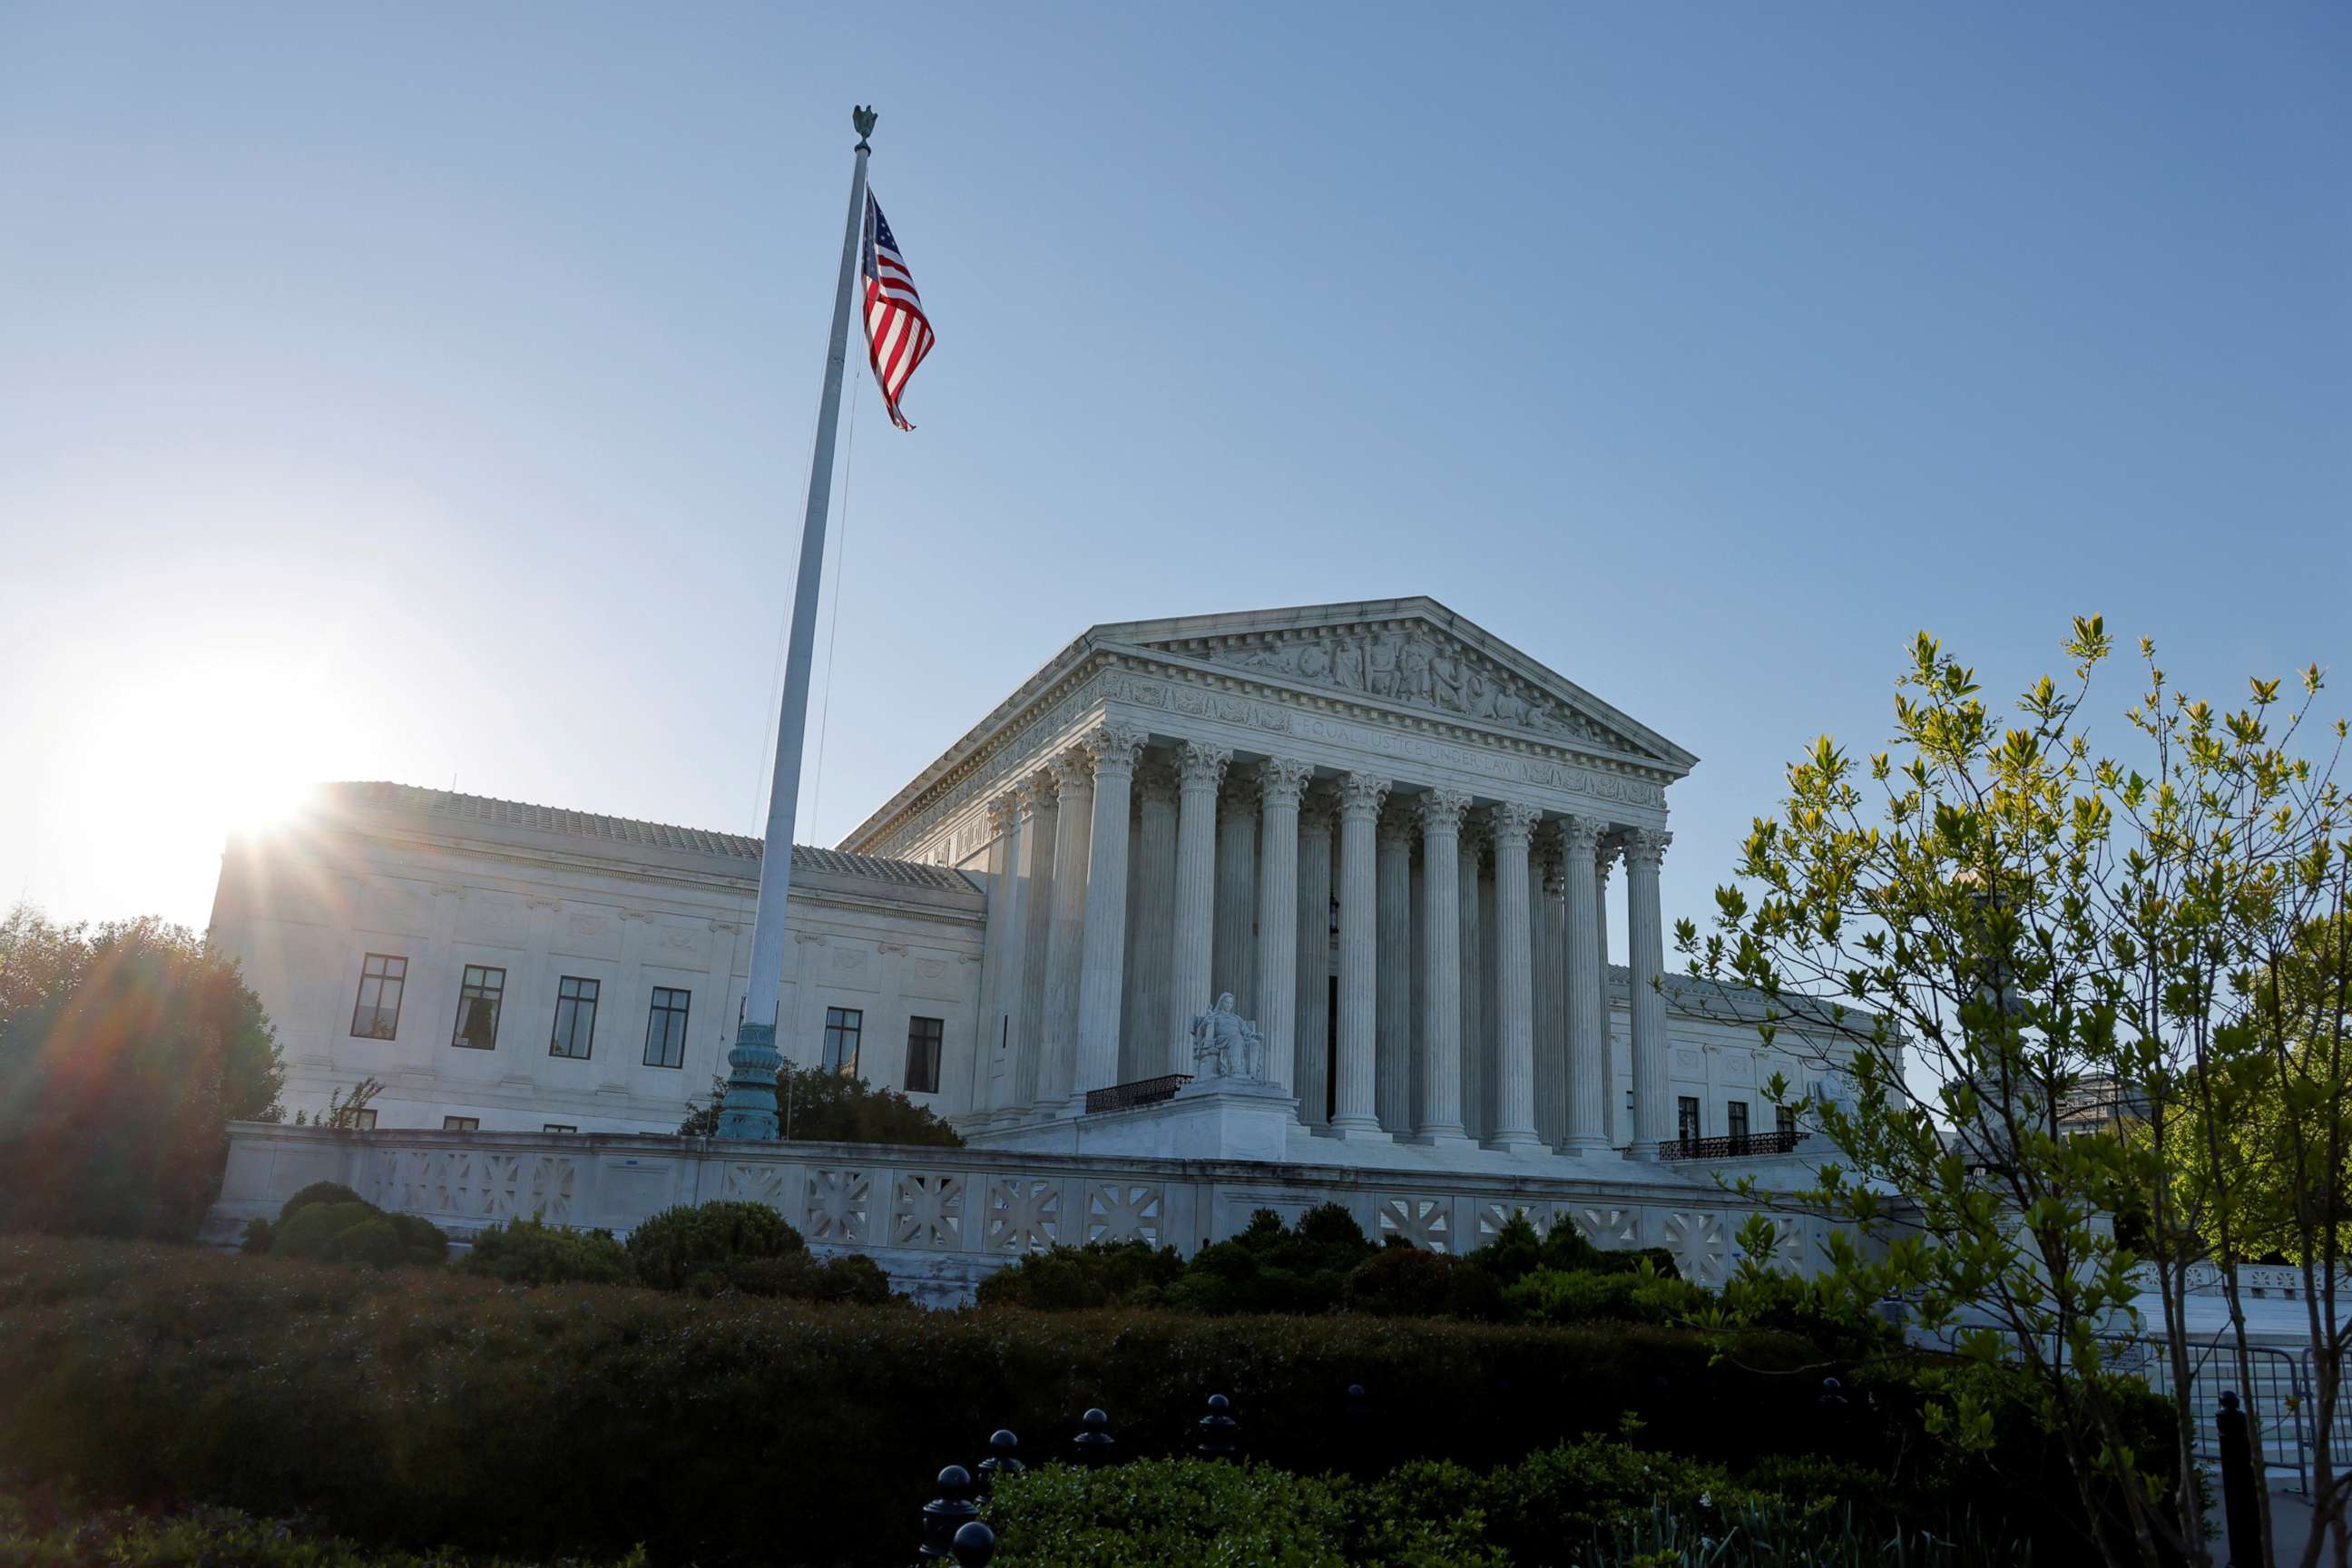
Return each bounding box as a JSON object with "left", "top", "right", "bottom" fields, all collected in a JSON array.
[{"left": 214, "top": 600, "right": 1872, "bottom": 1169}]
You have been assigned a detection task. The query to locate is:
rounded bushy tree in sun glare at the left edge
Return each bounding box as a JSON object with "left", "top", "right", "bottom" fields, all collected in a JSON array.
[{"left": 0, "top": 907, "right": 285, "bottom": 1239}]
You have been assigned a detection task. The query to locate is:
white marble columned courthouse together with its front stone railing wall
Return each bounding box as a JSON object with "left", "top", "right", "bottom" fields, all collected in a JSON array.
[{"left": 214, "top": 600, "right": 1842, "bottom": 1298}]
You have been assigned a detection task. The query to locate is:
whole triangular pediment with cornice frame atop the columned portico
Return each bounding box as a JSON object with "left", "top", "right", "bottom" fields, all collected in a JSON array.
[{"left": 1089, "top": 600, "right": 1696, "bottom": 776}]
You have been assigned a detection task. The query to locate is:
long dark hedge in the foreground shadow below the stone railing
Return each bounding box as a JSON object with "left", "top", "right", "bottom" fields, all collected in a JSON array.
[{"left": 0, "top": 1239, "right": 1818, "bottom": 1563}]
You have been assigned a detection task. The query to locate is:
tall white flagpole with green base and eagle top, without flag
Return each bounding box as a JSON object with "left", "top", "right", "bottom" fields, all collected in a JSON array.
[{"left": 720, "top": 106, "right": 875, "bottom": 1140}]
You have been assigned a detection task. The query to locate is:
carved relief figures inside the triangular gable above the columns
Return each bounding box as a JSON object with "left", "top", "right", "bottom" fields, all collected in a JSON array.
[{"left": 1185, "top": 630, "right": 1644, "bottom": 752}]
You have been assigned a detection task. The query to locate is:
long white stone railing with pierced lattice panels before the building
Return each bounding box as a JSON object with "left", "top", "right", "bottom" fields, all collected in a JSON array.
[{"left": 205, "top": 1122, "right": 1823, "bottom": 1302}]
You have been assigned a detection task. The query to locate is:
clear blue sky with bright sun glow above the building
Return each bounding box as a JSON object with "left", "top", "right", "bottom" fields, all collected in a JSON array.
[{"left": 0, "top": 0, "right": 2352, "bottom": 949}]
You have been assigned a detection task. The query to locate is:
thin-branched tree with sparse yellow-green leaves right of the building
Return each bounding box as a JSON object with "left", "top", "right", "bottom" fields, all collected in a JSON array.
[{"left": 1677, "top": 618, "right": 2343, "bottom": 1565}]
